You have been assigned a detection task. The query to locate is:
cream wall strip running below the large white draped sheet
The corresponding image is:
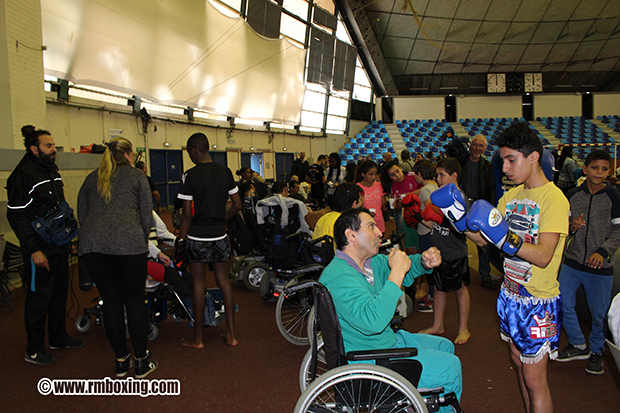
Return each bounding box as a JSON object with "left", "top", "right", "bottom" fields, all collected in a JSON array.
[{"left": 43, "top": 93, "right": 346, "bottom": 179}]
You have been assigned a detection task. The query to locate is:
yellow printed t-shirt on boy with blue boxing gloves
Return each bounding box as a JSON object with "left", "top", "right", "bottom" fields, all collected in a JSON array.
[{"left": 497, "top": 182, "right": 570, "bottom": 298}]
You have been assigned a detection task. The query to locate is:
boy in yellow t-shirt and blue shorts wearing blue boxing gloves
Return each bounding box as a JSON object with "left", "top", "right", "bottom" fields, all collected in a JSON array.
[{"left": 466, "top": 123, "right": 569, "bottom": 413}]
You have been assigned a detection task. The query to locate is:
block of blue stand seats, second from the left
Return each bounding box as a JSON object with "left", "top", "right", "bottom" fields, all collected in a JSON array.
[{"left": 396, "top": 119, "right": 451, "bottom": 156}]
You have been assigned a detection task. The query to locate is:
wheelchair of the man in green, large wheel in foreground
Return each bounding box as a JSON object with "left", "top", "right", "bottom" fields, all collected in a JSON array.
[{"left": 285, "top": 280, "right": 462, "bottom": 413}]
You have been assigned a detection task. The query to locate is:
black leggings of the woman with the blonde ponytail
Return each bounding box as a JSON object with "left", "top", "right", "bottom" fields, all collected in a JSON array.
[{"left": 82, "top": 253, "right": 149, "bottom": 358}]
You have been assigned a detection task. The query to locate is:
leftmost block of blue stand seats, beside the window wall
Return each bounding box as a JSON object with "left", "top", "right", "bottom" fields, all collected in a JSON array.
[{"left": 339, "top": 120, "right": 394, "bottom": 166}]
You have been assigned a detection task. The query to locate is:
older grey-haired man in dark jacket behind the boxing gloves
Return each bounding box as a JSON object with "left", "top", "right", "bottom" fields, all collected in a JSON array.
[{"left": 459, "top": 135, "right": 499, "bottom": 288}]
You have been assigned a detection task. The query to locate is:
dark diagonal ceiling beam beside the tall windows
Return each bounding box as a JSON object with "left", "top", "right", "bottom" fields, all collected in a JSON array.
[{"left": 335, "top": 0, "right": 398, "bottom": 96}]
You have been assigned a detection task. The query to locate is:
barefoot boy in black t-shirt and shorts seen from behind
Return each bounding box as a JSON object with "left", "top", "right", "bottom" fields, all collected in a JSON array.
[{"left": 178, "top": 133, "right": 241, "bottom": 348}]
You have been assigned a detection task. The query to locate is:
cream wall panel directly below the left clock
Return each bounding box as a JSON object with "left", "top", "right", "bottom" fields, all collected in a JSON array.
[{"left": 456, "top": 96, "right": 523, "bottom": 120}]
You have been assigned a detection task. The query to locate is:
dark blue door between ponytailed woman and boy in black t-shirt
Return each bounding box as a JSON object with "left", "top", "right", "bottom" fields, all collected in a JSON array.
[{"left": 150, "top": 149, "right": 183, "bottom": 208}]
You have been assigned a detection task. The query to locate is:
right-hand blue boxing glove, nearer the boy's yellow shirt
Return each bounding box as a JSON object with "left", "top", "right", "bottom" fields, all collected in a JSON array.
[{"left": 467, "top": 199, "right": 523, "bottom": 257}]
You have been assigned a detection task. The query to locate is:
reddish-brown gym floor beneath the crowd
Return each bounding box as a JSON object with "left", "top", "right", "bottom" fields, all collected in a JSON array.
[{"left": 0, "top": 214, "right": 620, "bottom": 413}]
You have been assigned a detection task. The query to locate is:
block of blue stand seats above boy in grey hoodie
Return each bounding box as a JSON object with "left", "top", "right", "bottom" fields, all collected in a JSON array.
[{"left": 537, "top": 116, "right": 616, "bottom": 158}]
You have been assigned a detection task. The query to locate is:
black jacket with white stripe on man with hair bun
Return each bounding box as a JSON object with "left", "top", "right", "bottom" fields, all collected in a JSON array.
[{"left": 6, "top": 153, "right": 70, "bottom": 257}]
